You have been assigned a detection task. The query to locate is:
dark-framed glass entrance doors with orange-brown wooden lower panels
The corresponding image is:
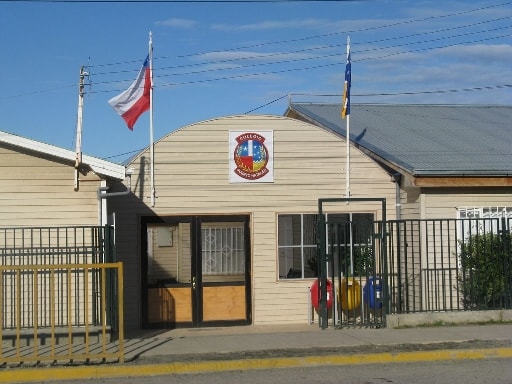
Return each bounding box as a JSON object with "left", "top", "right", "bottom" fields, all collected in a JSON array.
[{"left": 141, "top": 215, "right": 251, "bottom": 328}]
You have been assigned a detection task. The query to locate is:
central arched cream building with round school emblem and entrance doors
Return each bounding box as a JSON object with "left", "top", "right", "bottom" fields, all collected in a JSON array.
[{"left": 109, "top": 115, "right": 395, "bottom": 328}]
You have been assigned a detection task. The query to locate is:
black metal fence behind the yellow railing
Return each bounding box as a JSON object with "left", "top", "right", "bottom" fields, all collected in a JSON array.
[{"left": 0, "top": 226, "right": 116, "bottom": 329}]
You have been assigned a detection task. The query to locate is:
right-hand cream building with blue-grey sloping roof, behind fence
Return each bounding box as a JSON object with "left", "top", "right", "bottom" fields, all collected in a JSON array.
[{"left": 286, "top": 103, "right": 512, "bottom": 313}]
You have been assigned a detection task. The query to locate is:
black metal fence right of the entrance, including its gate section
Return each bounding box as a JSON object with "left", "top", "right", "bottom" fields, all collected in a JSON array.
[{"left": 318, "top": 207, "right": 512, "bottom": 327}]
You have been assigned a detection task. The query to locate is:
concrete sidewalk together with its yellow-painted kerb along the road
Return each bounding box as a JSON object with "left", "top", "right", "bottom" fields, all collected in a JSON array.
[{"left": 0, "top": 324, "right": 512, "bottom": 383}]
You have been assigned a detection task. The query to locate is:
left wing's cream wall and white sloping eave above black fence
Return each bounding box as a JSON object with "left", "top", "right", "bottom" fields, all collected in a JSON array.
[{"left": 0, "top": 131, "right": 125, "bottom": 227}]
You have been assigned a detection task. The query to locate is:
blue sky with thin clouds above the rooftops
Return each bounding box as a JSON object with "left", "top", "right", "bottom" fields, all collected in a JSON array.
[{"left": 0, "top": 0, "right": 512, "bottom": 163}]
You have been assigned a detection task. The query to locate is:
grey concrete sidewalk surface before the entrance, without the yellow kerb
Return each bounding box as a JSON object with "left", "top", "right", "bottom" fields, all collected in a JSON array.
[{"left": 125, "top": 324, "right": 512, "bottom": 360}]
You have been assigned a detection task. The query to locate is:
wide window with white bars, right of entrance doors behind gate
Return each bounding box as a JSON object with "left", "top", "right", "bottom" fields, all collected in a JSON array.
[{"left": 277, "top": 213, "right": 373, "bottom": 279}]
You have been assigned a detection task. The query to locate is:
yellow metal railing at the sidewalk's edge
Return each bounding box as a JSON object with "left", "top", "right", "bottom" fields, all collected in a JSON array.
[{"left": 0, "top": 263, "right": 124, "bottom": 364}]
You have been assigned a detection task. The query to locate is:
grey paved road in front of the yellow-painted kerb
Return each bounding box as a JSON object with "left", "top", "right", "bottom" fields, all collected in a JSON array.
[{"left": 27, "top": 359, "right": 512, "bottom": 384}]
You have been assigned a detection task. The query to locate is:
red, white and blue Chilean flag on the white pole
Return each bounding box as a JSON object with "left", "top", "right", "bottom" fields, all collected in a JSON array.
[{"left": 108, "top": 55, "right": 151, "bottom": 130}]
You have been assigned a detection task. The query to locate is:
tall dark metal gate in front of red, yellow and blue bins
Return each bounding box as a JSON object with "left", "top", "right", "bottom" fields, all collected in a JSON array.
[{"left": 317, "top": 198, "right": 387, "bottom": 329}]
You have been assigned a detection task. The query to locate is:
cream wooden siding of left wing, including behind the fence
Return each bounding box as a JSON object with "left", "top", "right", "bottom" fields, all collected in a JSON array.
[{"left": 0, "top": 146, "right": 116, "bottom": 327}]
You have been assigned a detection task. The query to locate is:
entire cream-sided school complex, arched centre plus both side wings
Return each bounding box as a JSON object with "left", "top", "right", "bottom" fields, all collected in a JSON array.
[{"left": 0, "top": 103, "right": 512, "bottom": 329}]
